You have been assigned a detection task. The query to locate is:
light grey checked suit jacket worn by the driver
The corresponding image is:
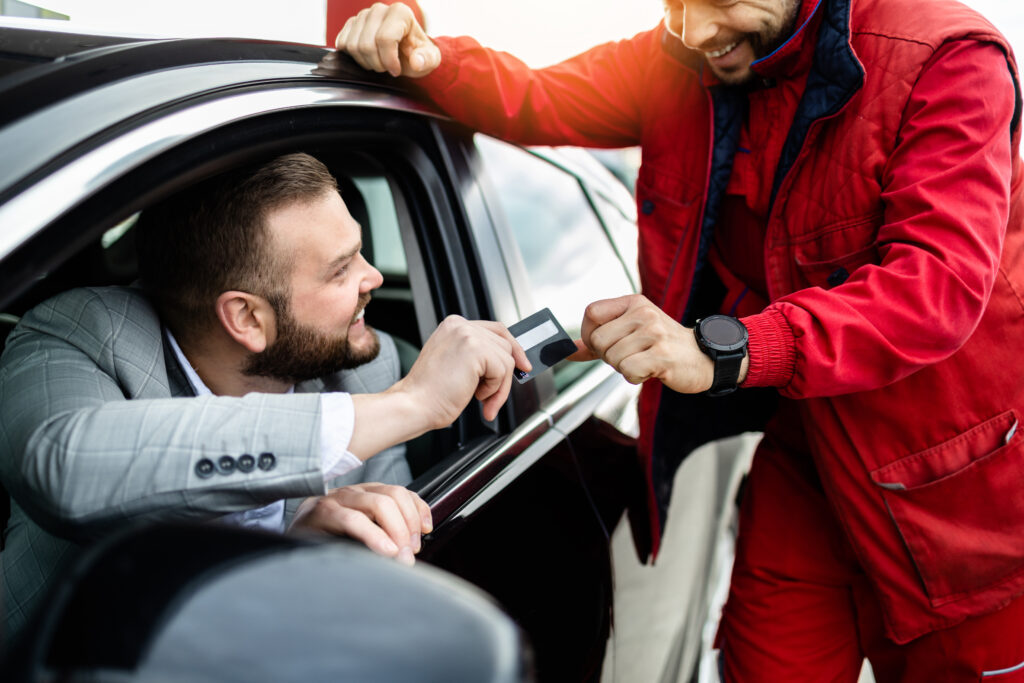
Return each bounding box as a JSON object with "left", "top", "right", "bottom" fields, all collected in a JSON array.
[{"left": 0, "top": 287, "right": 411, "bottom": 635}]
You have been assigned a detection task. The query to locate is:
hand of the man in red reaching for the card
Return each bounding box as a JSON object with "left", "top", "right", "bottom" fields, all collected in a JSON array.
[{"left": 569, "top": 294, "right": 746, "bottom": 393}]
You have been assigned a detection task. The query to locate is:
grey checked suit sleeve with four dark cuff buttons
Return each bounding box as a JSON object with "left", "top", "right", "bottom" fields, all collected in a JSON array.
[{"left": 0, "top": 290, "right": 324, "bottom": 539}]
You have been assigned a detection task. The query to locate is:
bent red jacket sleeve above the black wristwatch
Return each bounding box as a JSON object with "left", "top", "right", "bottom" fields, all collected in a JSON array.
[{"left": 743, "top": 41, "right": 1017, "bottom": 398}]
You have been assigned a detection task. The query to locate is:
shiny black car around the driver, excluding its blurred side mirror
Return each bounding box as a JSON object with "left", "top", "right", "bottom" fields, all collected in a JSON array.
[{"left": 0, "top": 17, "right": 742, "bottom": 682}]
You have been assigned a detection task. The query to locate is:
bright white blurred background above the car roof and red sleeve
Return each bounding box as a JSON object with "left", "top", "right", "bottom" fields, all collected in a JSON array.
[{"left": 0, "top": 0, "right": 1024, "bottom": 67}]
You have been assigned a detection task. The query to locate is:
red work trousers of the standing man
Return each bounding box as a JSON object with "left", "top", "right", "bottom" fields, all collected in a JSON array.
[{"left": 718, "top": 436, "right": 1024, "bottom": 683}]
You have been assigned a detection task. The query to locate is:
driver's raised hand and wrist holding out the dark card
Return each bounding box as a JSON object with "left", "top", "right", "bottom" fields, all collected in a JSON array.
[{"left": 348, "top": 315, "right": 531, "bottom": 460}]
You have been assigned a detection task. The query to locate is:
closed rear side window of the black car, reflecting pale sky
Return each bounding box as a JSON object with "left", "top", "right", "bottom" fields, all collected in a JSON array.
[{"left": 475, "top": 135, "right": 635, "bottom": 388}]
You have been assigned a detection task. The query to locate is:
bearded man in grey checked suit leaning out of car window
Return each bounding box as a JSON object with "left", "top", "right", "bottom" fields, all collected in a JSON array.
[{"left": 0, "top": 155, "right": 529, "bottom": 635}]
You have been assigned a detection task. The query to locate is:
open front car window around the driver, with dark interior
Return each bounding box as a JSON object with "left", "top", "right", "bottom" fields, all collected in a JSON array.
[{"left": 0, "top": 104, "right": 507, "bottom": 497}]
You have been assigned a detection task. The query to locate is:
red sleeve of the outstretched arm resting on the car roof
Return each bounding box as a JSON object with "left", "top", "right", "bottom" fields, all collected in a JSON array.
[{"left": 413, "top": 30, "right": 659, "bottom": 146}]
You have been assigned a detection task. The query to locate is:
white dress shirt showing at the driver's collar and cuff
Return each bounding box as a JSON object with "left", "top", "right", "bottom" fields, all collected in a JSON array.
[{"left": 164, "top": 328, "right": 362, "bottom": 532}]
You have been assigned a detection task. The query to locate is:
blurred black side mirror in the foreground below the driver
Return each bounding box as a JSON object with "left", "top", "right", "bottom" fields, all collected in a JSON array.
[{"left": 8, "top": 525, "right": 530, "bottom": 683}]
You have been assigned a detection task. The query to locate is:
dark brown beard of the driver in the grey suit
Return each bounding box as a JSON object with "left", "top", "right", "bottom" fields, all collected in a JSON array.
[{"left": 242, "top": 294, "right": 381, "bottom": 384}]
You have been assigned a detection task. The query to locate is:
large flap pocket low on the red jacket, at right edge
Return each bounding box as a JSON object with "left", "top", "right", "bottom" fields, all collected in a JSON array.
[{"left": 871, "top": 411, "right": 1024, "bottom": 607}]
